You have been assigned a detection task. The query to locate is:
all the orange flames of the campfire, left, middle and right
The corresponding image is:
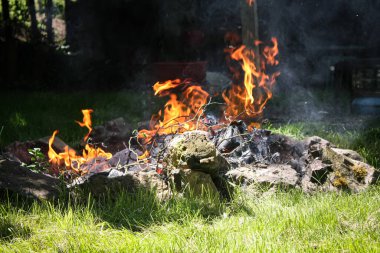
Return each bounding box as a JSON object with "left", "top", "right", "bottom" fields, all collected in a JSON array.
[{"left": 48, "top": 38, "right": 279, "bottom": 176}]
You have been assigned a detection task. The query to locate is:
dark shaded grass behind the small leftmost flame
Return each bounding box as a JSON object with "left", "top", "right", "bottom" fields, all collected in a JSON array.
[{"left": 0, "top": 91, "right": 157, "bottom": 148}]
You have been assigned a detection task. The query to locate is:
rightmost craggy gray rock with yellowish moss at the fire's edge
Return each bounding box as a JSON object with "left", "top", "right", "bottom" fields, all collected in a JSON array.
[{"left": 301, "top": 136, "right": 378, "bottom": 192}]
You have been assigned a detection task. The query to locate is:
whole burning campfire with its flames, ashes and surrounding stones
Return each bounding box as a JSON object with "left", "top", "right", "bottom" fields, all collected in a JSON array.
[{"left": 2, "top": 38, "right": 377, "bottom": 199}]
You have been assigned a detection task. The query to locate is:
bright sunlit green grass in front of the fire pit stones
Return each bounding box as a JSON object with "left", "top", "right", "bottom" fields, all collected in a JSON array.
[{"left": 0, "top": 187, "right": 380, "bottom": 252}]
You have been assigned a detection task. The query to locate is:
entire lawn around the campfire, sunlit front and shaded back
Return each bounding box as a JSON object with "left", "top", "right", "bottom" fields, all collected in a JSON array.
[{"left": 0, "top": 91, "right": 380, "bottom": 252}]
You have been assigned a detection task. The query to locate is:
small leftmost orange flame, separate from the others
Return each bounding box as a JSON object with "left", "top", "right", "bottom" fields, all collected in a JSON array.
[{"left": 48, "top": 109, "right": 112, "bottom": 174}]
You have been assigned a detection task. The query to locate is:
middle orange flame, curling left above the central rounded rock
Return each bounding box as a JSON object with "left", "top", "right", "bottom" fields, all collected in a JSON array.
[{"left": 138, "top": 79, "right": 209, "bottom": 143}]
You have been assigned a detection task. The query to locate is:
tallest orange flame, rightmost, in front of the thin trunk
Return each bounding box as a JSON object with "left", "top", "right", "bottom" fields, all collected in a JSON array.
[{"left": 222, "top": 38, "right": 279, "bottom": 118}]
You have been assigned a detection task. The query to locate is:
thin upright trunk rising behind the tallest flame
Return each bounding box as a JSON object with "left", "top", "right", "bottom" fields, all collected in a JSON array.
[{"left": 240, "top": 0, "right": 260, "bottom": 70}]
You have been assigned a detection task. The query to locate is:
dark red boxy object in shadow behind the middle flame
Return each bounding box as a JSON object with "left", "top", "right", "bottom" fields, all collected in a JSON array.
[{"left": 153, "top": 61, "right": 207, "bottom": 82}]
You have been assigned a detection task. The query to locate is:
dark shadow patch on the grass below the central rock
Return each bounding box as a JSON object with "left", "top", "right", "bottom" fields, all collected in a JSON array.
[{"left": 87, "top": 189, "right": 250, "bottom": 231}]
